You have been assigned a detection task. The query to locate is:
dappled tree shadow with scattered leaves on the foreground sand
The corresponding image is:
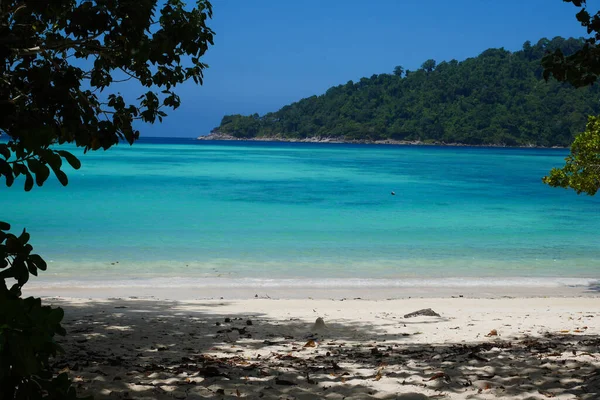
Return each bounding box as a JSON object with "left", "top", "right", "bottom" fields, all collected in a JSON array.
[{"left": 50, "top": 299, "right": 600, "bottom": 400}]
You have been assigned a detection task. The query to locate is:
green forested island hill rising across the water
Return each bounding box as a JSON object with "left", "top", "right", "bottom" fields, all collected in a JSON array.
[{"left": 207, "top": 37, "right": 600, "bottom": 147}]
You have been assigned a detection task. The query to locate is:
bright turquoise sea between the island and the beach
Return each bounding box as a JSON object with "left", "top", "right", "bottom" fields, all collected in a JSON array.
[{"left": 0, "top": 139, "right": 600, "bottom": 285}]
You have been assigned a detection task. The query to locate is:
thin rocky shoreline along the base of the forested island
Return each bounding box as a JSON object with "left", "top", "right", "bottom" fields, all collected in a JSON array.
[{"left": 196, "top": 133, "right": 568, "bottom": 149}]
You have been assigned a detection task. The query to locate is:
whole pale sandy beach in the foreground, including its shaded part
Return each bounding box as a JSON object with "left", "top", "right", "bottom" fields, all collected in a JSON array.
[{"left": 45, "top": 293, "right": 600, "bottom": 400}]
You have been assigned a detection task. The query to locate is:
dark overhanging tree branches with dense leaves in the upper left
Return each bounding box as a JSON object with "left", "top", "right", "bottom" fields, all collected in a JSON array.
[{"left": 0, "top": 0, "right": 213, "bottom": 190}]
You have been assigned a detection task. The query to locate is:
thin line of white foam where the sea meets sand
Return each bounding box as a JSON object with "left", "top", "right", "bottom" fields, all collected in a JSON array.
[{"left": 27, "top": 277, "right": 600, "bottom": 289}]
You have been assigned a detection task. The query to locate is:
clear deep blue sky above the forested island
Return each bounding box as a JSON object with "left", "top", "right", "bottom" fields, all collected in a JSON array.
[{"left": 139, "top": 0, "right": 600, "bottom": 137}]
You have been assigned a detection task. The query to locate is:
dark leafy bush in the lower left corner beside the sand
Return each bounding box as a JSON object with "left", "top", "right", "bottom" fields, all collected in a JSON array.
[{"left": 0, "top": 222, "right": 86, "bottom": 400}]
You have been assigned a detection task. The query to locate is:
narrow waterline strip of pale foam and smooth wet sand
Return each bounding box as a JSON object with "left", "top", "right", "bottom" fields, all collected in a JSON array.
[{"left": 23, "top": 280, "right": 600, "bottom": 300}]
